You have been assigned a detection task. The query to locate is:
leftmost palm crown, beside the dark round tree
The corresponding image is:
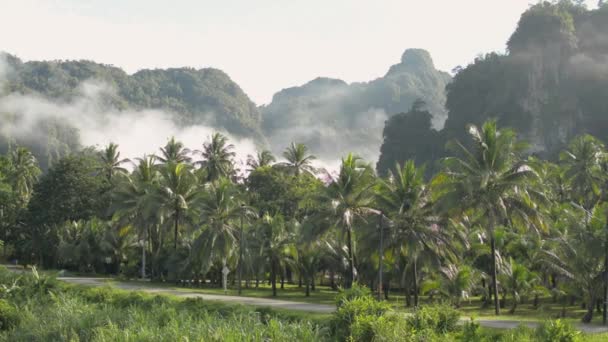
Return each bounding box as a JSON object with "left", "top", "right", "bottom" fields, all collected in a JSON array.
[{"left": 8, "top": 147, "right": 41, "bottom": 203}]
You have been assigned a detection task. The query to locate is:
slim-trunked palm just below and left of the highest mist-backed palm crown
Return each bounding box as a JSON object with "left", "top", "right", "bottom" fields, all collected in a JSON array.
[{"left": 152, "top": 162, "right": 199, "bottom": 251}]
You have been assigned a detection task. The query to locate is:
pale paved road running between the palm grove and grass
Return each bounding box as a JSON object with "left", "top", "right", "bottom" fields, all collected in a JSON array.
[{"left": 30, "top": 277, "right": 608, "bottom": 333}]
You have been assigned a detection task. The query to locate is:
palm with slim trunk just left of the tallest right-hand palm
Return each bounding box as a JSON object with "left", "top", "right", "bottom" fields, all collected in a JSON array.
[{"left": 377, "top": 160, "right": 456, "bottom": 306}]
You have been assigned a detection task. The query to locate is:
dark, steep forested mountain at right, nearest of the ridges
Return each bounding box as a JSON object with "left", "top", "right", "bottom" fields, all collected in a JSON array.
[{"left": 378, "top": 1, "right": 608, "bottom": 173}]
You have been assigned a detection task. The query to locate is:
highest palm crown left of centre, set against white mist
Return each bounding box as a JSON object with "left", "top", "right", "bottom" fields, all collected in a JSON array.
[{"left": 196, "top": 132, "right": 236, "bottom": 182}]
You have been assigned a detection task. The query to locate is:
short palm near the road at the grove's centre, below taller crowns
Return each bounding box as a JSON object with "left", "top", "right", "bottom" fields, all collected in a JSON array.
[{"left": 255, "top": 214, "right": 297, "bottom": 297}]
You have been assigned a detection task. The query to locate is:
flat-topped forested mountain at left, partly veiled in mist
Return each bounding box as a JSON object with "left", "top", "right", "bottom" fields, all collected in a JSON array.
[{"left": 0, "top": 54, "right": 266, "bottom": 167}]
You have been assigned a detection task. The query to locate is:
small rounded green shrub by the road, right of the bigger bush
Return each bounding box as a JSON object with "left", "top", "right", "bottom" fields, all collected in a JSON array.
[{"left": 407, "top": 305, "right": 460, "bottom": 334}]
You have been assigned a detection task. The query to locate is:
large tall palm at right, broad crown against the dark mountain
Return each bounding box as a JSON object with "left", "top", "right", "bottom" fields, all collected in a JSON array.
[{"left": 435, "top": 120, "right": 545, "bottom": 315}]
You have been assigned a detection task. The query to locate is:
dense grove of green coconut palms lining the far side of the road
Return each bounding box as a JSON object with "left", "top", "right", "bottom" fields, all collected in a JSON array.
[{"left": 3, "top": 121, "right": 608, "bottom": 321}]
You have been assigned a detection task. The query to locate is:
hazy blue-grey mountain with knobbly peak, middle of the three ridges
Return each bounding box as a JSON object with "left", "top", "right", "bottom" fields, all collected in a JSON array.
[{"left": 260, "top": 49, "right": 451, "bottom": 159}]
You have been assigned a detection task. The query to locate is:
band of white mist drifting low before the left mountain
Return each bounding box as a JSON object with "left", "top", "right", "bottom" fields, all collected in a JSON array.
[{"left": 0, "top": 62, "right": 256, "bottom": 167}]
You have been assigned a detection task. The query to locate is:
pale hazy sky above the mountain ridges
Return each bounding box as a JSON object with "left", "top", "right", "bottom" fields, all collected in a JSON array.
[{"left": 0, "top": 0, "right": 597, "bottom": 104}]
